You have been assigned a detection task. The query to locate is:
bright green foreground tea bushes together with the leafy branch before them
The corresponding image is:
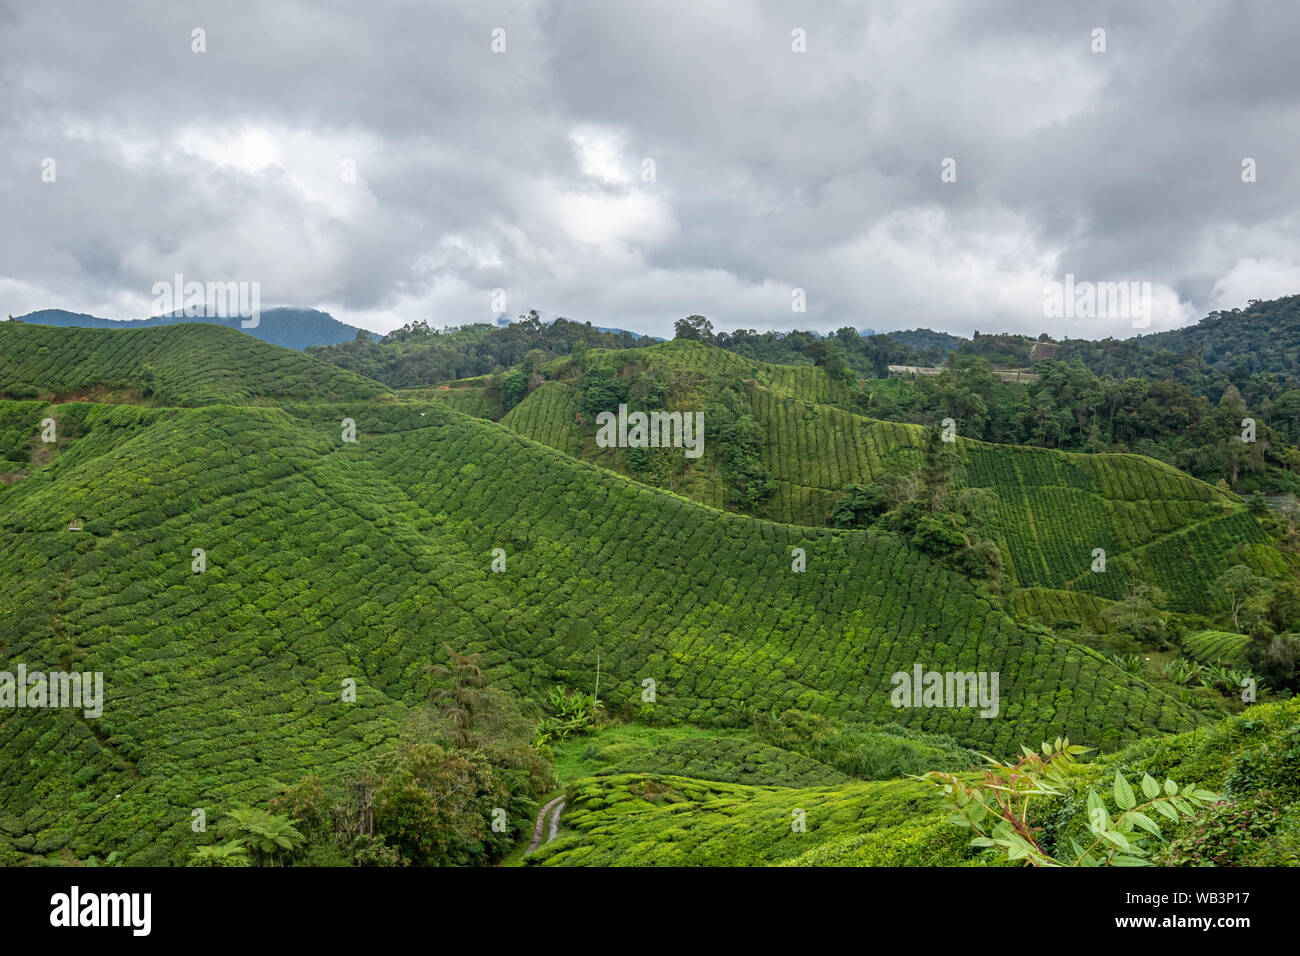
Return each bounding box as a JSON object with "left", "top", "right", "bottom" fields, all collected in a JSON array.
[{"left": 524, "top": 700, "right": 1300, "bottom": 866}]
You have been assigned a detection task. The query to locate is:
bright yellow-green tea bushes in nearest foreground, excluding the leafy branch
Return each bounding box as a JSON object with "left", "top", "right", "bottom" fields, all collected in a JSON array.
[{"left": 523, "top": 700, "right": 1300, "bottom": 866}]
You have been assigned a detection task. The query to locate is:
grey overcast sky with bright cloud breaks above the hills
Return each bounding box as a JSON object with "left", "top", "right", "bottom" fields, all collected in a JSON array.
[{"left": 0, "top": 0, "right": 1300, "bottom": 338}]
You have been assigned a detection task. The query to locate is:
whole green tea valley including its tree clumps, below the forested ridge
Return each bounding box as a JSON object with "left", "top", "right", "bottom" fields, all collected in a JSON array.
[{"left": 0, "top": 317, "right": 1300, "bottom": 866}]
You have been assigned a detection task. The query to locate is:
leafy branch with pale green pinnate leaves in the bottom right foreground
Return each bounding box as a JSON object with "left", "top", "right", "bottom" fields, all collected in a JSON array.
[{"left": 917, "top": 737, "right": 1221, "bottom": 866}]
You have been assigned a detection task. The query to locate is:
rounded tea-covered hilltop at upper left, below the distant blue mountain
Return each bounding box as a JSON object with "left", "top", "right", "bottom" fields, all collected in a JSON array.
[{"left": 0, "top": 323, "right": 389, "bottom": 406}]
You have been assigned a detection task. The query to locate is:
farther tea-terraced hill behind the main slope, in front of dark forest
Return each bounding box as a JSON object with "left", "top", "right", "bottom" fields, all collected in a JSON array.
[{"left": 502, "top": 341, "right": 1292, "bottom": 610}]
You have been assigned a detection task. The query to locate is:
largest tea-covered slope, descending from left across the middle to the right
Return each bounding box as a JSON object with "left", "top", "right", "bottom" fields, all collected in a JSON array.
[{"left": 0, "top": 382, "right": 1199, "bottom": 862}]
